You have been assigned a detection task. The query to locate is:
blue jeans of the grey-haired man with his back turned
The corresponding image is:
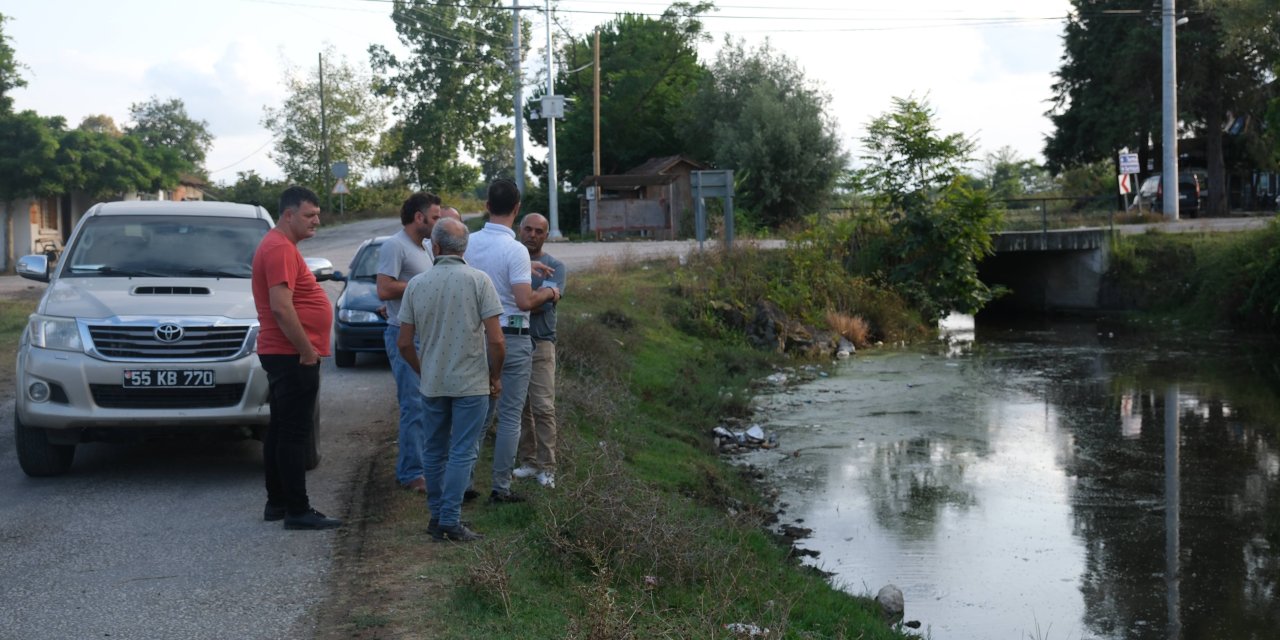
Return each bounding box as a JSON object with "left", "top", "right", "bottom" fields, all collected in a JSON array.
[{"left": 419, "top": 396, "right": 489, "bottom": 527}]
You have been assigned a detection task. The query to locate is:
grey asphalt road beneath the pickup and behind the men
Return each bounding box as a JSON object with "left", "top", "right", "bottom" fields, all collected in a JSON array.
[{"left": 0, "top": 219, "right": 732, "bottom": 640}]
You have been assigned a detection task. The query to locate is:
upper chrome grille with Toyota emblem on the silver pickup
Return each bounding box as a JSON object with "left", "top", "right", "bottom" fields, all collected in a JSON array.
[{"left": 88, "top": 325, "right": 250, "bottom": 360}]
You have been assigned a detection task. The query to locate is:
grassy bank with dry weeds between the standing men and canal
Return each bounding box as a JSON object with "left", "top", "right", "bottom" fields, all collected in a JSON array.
[{"left": 320, "top": 255, "right": 921, "bottom": 639}]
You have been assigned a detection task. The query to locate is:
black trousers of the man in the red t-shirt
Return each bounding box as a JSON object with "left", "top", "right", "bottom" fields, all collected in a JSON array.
[{"left": 257, "top": 353, "right": 320, "bottom": 516}]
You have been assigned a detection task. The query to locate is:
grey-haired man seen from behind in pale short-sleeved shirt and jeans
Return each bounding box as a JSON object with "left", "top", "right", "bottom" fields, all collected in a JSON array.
[{"left": 396, "top": 219, "right": 504, "bottom": 541}]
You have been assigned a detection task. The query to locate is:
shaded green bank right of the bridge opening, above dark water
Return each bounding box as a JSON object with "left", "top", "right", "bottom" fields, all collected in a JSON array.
[{"left": 1102, "top": 223, "right": 1280, "bottom": 332}]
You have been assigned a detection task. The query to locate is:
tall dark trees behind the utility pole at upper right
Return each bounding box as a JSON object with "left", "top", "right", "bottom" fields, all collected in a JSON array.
[{"left": 1044, "top": 0, "right": 1280, "bottom": 215}]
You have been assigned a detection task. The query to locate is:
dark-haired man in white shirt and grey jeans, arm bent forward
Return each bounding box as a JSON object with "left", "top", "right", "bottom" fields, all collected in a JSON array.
[{"left": 466, "top": 179, "right": 559, "bottom": 503}]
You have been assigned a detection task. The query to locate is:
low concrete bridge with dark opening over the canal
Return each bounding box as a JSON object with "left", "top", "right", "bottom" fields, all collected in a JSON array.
[{"left": 978, "top": 215, "right": 1274, "bottom": 312}]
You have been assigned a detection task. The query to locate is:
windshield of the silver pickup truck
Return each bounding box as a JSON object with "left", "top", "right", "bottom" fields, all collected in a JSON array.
[{"left": 63, "top": 215, "right": 270, "bottom": 278}]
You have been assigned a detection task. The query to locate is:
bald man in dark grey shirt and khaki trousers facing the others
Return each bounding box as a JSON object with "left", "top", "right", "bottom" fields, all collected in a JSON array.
[{"left": 512, "top": 214, "right": 568, "bottom": 489}]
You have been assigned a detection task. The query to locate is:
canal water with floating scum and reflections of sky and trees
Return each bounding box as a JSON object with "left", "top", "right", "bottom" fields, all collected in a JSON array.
[{"left": 742, "top": 321, "right": 1280, "bottom": 640}]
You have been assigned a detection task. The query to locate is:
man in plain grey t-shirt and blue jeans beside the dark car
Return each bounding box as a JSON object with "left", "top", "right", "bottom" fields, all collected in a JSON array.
[{"left": 378, "top": 193, "right": 440, "bottom": 493}]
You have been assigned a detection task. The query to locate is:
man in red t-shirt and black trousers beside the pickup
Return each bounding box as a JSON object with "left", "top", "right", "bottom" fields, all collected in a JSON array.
[{"left": 253, "top": 187, "right": 342, "bottom": 529}]
